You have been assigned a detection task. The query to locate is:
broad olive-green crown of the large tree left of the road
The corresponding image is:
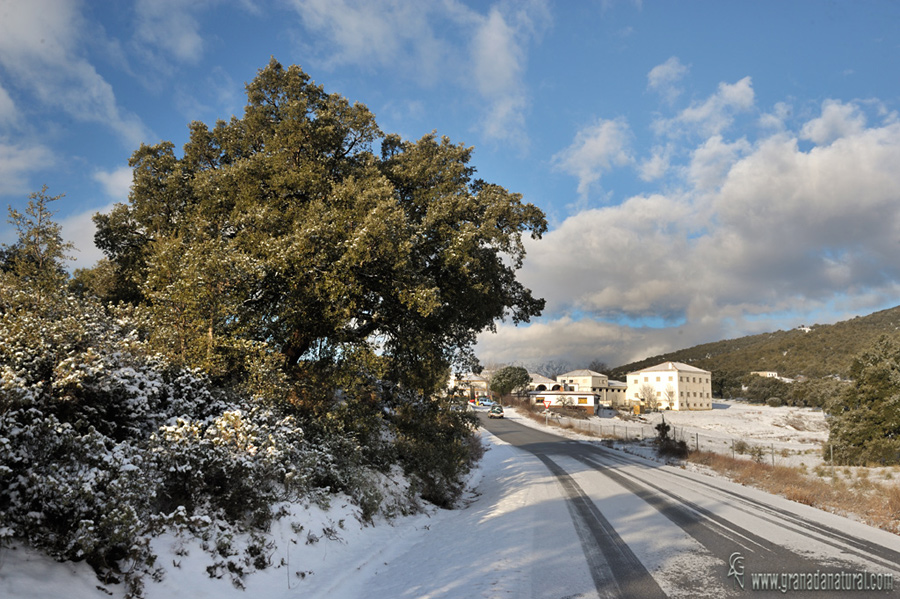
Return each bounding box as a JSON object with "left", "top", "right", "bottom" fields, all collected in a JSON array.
[{"left": 95, "top": 59, "right": 546, "bottom": 393}]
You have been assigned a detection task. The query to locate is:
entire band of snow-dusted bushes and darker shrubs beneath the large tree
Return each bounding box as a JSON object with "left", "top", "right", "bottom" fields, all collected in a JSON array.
[{"left": 0, "top": 276, "right": 486, "bottom": 596}]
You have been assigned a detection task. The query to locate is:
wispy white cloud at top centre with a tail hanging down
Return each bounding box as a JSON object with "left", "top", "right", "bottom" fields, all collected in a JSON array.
[{"left": 291, "top": 0, "right": 550, "bottom": 144}]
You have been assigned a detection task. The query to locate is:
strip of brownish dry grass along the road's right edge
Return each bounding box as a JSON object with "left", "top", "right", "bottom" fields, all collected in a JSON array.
[{"left": 688, "top": 452, "right": 900, "bottom": 534}]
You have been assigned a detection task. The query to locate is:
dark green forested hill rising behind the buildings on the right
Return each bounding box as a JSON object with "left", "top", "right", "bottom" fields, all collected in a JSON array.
[{"left": 610, "top": 306, "right": 900, "bottom": 379}]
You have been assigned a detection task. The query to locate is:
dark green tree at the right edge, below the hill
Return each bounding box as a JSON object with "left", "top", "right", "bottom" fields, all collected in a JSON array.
[{"left": 826, "top": 337, "right": 900, "bottom": 465}]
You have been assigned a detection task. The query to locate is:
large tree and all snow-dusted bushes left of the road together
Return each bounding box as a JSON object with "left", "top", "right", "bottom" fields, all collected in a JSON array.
[{"left": 0, "top": 60, "right": 546, "bottom": 596}]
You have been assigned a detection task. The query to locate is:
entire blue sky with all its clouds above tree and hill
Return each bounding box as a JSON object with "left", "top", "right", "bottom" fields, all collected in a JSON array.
[{"left": 0, "top": 0, "right": 900, "bottom": 367}]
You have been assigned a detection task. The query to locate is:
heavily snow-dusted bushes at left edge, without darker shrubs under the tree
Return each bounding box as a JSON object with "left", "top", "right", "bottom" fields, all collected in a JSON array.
[{"left": 0, "top": 290, "right": 330, "bottom": 593}]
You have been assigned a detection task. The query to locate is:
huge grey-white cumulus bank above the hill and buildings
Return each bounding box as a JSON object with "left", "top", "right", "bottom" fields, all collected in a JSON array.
[{"left": 479, "top": 101, "right": 900, "bottom": 364}]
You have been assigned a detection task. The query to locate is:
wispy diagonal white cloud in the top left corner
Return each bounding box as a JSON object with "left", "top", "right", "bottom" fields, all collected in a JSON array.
[{"left": 0, "top": 0, "right": 146, "bottom": 146}]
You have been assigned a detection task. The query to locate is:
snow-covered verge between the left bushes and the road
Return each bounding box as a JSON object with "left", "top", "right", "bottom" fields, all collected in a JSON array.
[{"left": 0, "top": 433, "right": 593, "bottom": 599}]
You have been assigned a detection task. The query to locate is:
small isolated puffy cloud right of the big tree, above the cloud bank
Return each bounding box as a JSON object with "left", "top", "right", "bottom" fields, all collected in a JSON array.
[{"left": 552, "top": 119, "right": 633, "bottom": 197}]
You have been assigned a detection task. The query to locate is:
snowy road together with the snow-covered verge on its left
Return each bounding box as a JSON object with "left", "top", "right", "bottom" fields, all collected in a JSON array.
[{"left": 0, "top": 412, "right": 900, "bottom": 599}]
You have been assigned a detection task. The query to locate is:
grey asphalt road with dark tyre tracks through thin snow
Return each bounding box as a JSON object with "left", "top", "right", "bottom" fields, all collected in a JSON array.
[{"left": 479, "top": 414, "right": 900, "bottom": 598}]
